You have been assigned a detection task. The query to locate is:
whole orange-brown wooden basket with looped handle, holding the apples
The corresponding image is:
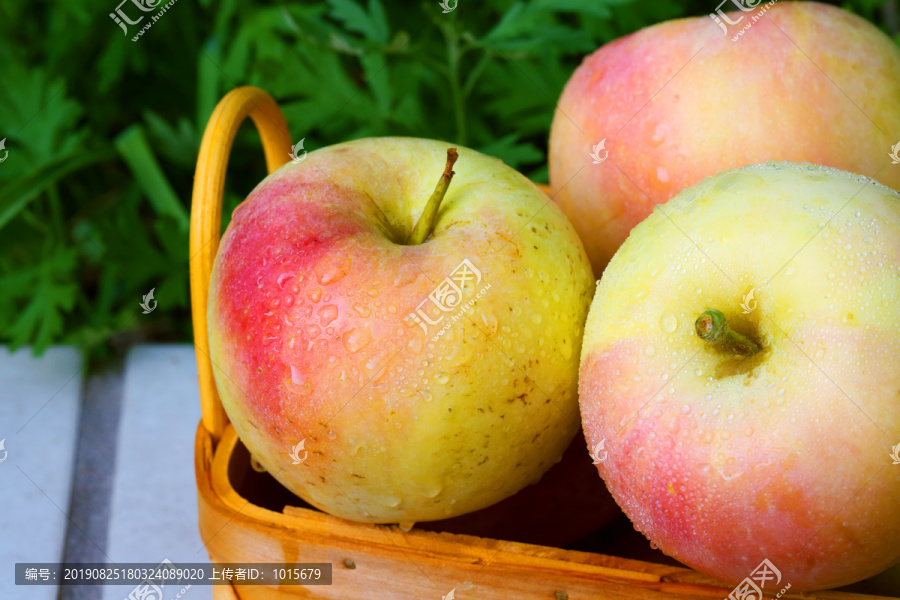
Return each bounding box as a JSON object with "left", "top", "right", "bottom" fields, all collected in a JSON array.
[{"left": 190, "top": 87, "right": 892, "bottom": 600}]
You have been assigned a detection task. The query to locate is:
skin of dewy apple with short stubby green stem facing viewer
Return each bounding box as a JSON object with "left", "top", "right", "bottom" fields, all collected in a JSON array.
[{"left": 579, "top": 163, "right": 900, "bottom": 592}]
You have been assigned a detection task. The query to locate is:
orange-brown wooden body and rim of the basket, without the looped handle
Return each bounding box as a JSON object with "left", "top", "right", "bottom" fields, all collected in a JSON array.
[{"left": 195, "top": 425, "right": 892, "bottom": 600}]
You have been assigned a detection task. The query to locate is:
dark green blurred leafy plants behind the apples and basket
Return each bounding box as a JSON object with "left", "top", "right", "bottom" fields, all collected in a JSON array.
[{"left": 0, "top": 0, "right": 900, "bottom": 369}]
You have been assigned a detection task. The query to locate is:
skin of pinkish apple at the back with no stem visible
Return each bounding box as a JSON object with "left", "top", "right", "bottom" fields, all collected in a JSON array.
[{"left": 548, "top": 2, "right": 900, "bottom": 276}]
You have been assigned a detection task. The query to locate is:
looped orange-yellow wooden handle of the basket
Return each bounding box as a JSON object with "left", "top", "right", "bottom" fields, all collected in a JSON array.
[{"left": 190, "top": 86, "right": 291, "bottom": 444}]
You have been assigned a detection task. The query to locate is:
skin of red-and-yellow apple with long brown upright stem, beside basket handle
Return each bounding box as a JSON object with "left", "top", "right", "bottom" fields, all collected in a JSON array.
[{"left": 208, "top": 138, "right": 594, "bottom": 525}]
